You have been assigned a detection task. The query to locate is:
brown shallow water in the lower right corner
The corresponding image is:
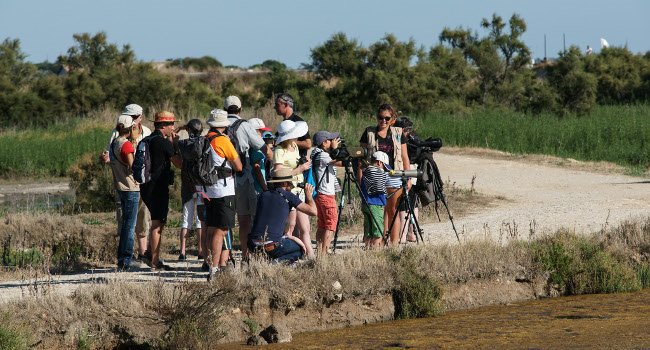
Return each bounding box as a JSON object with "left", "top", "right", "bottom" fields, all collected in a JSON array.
[{"left": 235, "top": 289, "right": 650, "bottom": 349}]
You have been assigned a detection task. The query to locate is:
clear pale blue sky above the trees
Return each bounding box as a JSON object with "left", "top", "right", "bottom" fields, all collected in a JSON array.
[{"left": 0, "top": 0, "right": 650, "bottom": 68}]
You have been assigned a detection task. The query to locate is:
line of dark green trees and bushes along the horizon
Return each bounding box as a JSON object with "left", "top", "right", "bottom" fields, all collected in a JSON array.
[{"left": 0, "top": 14, "right": 650, "bottom": 128}]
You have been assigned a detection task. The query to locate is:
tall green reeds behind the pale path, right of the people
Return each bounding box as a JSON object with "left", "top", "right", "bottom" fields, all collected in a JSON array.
[{"left": 415, "top": 105, "right": 650, "bottom": 173}]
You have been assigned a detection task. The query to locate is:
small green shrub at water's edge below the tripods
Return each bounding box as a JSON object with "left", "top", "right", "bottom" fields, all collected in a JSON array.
[{"left": 391, "top": 248, "right": 443, "bottom": 319}]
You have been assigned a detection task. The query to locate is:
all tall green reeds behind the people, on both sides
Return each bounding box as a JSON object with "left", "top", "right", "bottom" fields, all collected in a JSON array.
[{"left": 0, "top": 105, "right": 650, "bottom": 178}]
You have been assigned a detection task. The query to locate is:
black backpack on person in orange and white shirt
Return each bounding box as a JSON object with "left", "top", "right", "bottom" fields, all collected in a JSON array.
[{"left": 178, "top": 134, "right": 232, "bottom": 187}]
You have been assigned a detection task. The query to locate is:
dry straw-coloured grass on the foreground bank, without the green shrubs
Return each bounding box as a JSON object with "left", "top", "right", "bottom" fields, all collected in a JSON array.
[{"left": 3, "top": 218, "right": 650, "bottom": 348}]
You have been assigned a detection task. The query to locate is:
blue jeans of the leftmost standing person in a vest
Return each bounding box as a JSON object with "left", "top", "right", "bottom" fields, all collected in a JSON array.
[{"left": 117, "top": 191, "right": 140, "bottom": 268}]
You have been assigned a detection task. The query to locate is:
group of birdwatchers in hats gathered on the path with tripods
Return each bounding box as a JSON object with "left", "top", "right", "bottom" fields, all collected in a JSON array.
[{"left": 101, "top": 93, "right": 420, "bottom": 278}]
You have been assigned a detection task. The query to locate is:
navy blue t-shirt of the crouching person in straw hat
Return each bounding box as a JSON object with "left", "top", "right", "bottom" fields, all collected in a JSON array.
[{"left": 248, "top": 188, "right": 302, "bottom": 245}]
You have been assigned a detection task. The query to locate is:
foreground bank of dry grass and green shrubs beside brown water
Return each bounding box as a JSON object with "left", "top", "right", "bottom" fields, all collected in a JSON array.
[{"left": 0, "top": 218, "right": 650, "bottom": 348}]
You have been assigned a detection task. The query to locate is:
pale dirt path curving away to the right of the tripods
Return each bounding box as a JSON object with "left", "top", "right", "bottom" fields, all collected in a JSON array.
[{"left": 423, "top": 153, "right": 650, "bottom": 243}]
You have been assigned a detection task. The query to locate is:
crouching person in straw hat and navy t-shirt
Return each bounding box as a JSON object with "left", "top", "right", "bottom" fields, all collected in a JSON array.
[{"left": 248, "top": 166, "right": 317, "bottom": 263}]
